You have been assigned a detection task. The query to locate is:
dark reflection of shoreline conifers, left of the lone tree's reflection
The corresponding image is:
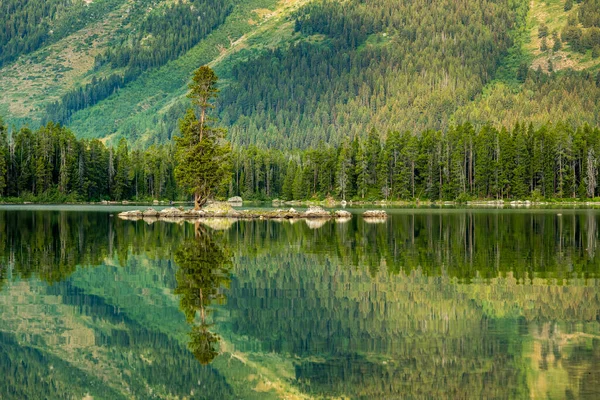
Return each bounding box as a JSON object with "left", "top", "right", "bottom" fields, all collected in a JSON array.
[{"left": 0, "top": 210, "right": 194, "bottom": 285}]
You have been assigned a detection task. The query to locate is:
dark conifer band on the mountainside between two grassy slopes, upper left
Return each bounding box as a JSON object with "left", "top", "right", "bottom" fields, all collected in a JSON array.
[{"left": 45, "top": 0, "right": 231, "bottom": 123}]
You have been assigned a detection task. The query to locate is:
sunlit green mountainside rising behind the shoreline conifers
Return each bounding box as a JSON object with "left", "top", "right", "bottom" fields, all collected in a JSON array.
[{"left": 0, "top": 0, "right": 600, "bottom": 148}]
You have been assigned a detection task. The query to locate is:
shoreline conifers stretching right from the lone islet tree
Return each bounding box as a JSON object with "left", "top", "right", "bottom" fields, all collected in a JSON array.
[{"left": 229, "top": 122, "right": 600, "bottom": 202}]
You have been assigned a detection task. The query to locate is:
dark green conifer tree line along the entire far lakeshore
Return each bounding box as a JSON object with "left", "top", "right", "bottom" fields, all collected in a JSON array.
[{"left": 5, "top": 115, "right": 600, "bottom": 201}]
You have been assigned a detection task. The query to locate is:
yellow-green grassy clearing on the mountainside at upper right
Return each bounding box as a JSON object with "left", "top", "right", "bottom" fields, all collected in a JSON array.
[{"left": 453, "top": 0, "right": 600, "bottom": 125}]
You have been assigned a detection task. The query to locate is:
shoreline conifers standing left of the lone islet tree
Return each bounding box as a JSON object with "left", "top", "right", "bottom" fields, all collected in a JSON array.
[{"left": 0, "top": 122, "right": 178, "bottom": 203}]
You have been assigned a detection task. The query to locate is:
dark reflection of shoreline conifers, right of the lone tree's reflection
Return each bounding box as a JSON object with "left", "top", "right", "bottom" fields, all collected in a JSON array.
[{"left": 229, "top": 209, "right": 600, "bottom": 281}]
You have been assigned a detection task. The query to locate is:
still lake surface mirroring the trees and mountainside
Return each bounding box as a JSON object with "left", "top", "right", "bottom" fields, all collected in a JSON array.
[{"left": 0, "top": 206, "right": 600, "bottom": 399}]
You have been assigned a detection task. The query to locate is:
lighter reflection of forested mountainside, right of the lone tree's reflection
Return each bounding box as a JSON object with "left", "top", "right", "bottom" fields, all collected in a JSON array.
[{"left": 226, "top": 252, "right": 600, "bottom": 399}]
